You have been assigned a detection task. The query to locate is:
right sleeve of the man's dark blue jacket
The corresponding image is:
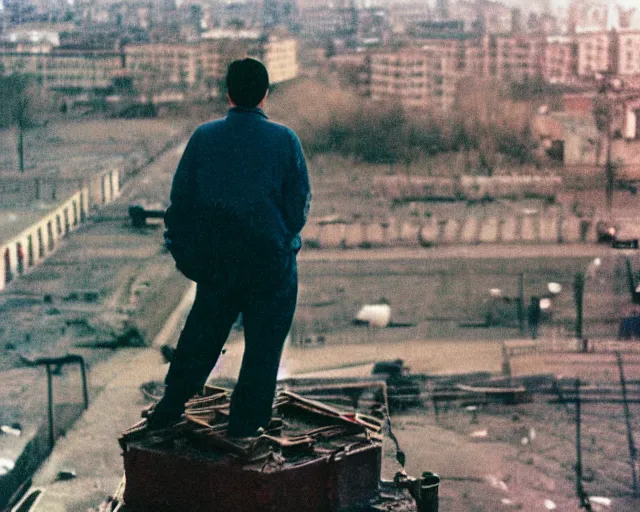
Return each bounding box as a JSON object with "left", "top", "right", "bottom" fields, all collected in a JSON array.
[{"left": 283, "top": 132, "right": 311, "bottom": 240}]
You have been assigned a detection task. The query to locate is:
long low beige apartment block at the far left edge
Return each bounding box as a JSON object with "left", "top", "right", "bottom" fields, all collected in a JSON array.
[{"left": 0, "top": 45, "right": 123, "bottom": 91}]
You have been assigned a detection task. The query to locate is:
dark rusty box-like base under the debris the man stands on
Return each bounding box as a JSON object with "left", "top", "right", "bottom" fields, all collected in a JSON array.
[{"left": 124, "top": 442, "right": 382, "bottom": 512}]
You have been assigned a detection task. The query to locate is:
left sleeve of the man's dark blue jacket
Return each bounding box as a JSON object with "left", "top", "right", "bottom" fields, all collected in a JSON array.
[{"left": 164, "top": 130, "right": 198, "bottom": 238}]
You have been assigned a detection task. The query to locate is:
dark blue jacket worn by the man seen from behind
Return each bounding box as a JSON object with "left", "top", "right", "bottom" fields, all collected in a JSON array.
[{"left": 165, "top": 107, "right": 311, "bottom": 277}]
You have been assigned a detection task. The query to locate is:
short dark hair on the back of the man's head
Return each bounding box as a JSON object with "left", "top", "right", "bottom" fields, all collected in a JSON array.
[{"left": 227, "top": 58, "right": 269, "bottom": 108}]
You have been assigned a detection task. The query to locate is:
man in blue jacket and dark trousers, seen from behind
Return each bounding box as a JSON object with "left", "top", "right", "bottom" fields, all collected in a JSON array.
[{"left": 148, "top": 59, "right": 311, "bottom": 437}]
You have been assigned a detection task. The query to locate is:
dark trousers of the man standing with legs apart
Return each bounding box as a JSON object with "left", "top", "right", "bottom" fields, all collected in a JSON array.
[{"left": 163, "top": 254, "right": 298, "bottom": 437}]
